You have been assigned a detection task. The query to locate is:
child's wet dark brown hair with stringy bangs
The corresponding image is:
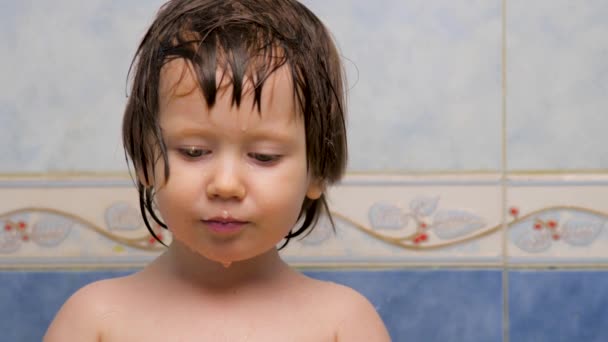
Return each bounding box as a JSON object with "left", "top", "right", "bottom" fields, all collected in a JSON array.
[{"left": 123, "top": 0, "right": 347, "bottom": 248}]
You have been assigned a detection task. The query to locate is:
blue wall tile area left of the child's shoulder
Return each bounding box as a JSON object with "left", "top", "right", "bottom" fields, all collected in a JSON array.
[{"left": 0, "top": 271, "right": 134, "bottom": 342}]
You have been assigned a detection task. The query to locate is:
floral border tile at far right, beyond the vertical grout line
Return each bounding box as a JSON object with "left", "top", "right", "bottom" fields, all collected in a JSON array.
[{"left": 508, "top": 175, "right": 608, "bottom": 266}]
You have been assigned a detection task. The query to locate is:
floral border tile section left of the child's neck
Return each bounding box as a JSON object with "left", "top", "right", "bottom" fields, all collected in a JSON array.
[{"left": 0, "top": 180, "right": 162, "bottom": 268}]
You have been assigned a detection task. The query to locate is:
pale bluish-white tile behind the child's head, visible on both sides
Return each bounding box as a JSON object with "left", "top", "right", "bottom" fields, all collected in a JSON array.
[{"left": 0, "top": 0, "right": 501, "bottom": 173}]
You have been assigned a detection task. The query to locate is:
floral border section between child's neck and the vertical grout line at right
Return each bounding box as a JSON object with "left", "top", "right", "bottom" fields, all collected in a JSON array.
[{"left": 284, "top": 175, "right": 502, "bottom": 266}]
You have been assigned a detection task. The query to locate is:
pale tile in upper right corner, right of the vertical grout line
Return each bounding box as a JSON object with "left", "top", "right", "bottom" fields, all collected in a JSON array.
[{"left": 507, "top": 0, "right": 608, "bottom": 170}]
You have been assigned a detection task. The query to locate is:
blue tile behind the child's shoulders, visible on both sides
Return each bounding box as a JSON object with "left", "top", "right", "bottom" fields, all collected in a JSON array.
[{"left": 0, "top": 270, "right": 502, "bottom": 342}]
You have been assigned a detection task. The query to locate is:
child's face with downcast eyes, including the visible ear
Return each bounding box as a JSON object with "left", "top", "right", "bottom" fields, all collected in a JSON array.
[{"left": 154, "top": 60, "right": 322, "bottom": 263}]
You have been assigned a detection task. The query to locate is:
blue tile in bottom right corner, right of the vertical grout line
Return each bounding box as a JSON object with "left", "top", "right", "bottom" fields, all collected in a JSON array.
[{"left": 509, "top": 271, "right": 608, "bottom": 342}]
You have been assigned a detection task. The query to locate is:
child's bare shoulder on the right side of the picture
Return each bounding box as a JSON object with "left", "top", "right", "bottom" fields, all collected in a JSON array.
[{"left": 302, "top": 280, "right": 391, "bottom": 342}]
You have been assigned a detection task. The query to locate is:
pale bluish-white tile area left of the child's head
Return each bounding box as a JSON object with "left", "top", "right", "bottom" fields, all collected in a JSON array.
[{"left": 0, "top": 0, "right": 163, "bottom": 173}]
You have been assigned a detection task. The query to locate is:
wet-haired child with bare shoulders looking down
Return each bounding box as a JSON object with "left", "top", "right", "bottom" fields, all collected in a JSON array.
[{"left": 45, "top": 0, "right": 390, "bottom": 342}]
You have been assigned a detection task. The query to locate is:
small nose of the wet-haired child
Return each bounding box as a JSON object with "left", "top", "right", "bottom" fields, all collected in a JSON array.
[{"left": 207, "top": 159, "right": 246, "bottom": 199}]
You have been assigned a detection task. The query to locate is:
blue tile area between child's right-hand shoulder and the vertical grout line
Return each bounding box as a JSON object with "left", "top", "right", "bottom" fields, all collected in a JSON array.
[{"left": 305, "top": 270, "right": 503, "bottom": 342}]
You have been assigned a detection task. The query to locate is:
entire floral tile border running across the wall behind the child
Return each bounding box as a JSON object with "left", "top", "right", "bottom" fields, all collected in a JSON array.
[{"left": 0, "top": 174, "right": 608, "bottom": 268}]
